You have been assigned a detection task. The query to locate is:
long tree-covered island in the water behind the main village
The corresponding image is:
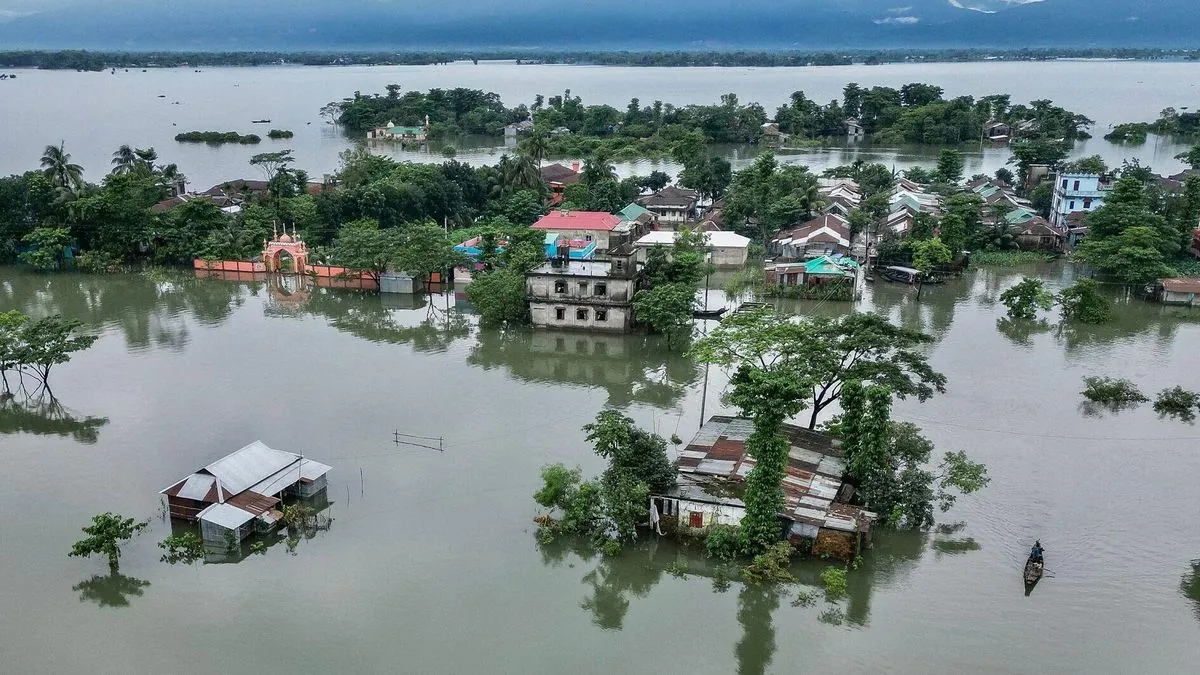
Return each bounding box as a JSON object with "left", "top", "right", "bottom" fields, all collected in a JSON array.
[{"left": 333, "top": 83, "right": 1093, "bottom": 159}]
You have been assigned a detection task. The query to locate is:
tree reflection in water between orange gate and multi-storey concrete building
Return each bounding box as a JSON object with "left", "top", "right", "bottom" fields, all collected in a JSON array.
[{"left": 302, "top": 288, "right": 472, "bottom": 352}]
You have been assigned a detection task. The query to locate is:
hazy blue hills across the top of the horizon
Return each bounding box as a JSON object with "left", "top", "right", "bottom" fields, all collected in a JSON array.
[{"left": 0, "top": 0, "right": 1200, "bottom": 50}]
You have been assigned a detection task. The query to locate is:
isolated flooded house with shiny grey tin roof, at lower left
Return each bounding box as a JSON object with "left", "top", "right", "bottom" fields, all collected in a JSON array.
[{"left": 160, "top": 441, "right": 331, "bottom": 546}]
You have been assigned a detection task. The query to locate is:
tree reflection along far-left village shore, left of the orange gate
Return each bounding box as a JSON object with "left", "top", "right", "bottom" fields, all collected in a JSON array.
[{"left": 0, "top": 268, "right": 248, "bottom": 350}]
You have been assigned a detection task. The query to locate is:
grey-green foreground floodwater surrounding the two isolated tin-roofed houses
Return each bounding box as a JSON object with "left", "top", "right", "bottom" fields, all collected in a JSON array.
[{"left": 0, "top": 264, "right": 1200, "bottom": 674}]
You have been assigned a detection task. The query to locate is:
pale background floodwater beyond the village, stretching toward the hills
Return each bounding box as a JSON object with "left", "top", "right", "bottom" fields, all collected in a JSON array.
[{"left": 0, "top": 61, "right": 1200, "bottom": 190}]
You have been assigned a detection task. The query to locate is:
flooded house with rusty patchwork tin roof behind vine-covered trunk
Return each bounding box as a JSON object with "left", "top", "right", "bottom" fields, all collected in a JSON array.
[{"left": 650, "top": 416, "right": 875, "bottom": 558}]
